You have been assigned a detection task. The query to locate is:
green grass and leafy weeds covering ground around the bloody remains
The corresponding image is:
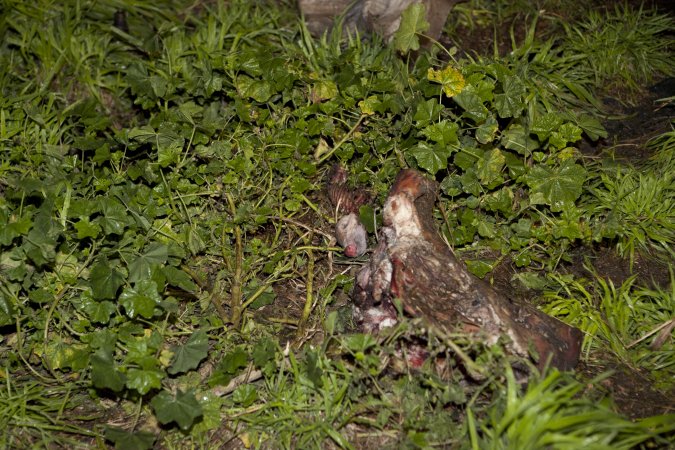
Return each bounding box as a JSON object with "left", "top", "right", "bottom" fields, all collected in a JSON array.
[{"left": 0, "top": 0, "right": 675, "bottom": 449}]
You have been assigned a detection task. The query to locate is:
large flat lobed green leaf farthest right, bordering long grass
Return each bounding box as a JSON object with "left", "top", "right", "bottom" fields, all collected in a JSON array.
[{"left": 525, "top": 160, "right": 586, "bottom": 212}]
